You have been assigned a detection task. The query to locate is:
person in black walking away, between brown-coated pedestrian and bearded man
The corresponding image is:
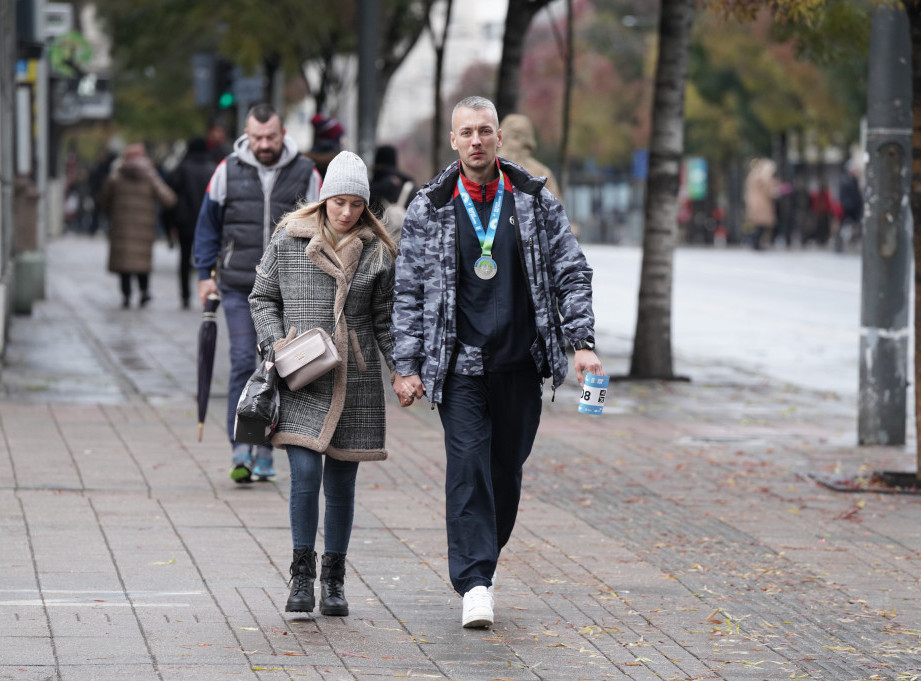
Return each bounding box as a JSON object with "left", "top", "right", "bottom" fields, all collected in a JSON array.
[{"left": 168, "top": 137, "right": 217, "bottom": 310}]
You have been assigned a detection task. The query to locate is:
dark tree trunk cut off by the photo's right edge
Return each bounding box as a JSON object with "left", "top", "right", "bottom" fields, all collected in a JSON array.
[{"left": 903, "top": 0, "right": 921, "bottom": 480}]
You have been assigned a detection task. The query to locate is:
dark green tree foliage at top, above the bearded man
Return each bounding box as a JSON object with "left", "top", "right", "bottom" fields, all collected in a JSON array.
[{"left": 97, "top": 0, "right": 433, "bottom": 141}]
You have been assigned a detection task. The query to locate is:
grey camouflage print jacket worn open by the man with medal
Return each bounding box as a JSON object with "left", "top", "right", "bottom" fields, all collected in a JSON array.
[{"left": 391, "top": 158, "right": 595, "bottom": 404}]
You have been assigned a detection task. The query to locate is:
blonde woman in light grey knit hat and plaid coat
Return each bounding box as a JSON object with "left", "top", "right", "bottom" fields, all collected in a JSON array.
[{"left": 249, "top": 151, "right": 396, "bottom": 616}]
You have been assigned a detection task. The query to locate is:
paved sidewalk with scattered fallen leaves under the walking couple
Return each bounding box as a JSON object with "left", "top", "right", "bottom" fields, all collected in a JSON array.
[{"left": 0, "top": 237, "right": 921, "bottom": 681}]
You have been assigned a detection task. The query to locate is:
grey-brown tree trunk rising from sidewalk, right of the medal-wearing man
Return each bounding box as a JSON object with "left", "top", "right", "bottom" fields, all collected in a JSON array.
[{"left": 630, "top": 0, "right": 695, "bottom": 379}]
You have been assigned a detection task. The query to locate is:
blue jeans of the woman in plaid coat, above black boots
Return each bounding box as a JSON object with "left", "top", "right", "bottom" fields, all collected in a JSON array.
[{"left": 286, "top": 445, "right": 358, "bottom": 554}]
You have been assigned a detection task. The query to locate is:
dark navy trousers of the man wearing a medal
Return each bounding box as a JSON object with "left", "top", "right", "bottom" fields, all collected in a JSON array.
[{"left": 438, "top": 370, "right": 542, "bottom": 594}]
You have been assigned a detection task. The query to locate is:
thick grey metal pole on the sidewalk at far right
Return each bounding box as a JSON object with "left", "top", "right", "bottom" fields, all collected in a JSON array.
[{"left": 857, "top": 4, "right": 912, "bottom": 445}]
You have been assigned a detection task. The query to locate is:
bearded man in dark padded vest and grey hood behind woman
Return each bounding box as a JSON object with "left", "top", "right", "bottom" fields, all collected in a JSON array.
[{"left": 193, "top": 104, "right": 321, "bottom": 483}]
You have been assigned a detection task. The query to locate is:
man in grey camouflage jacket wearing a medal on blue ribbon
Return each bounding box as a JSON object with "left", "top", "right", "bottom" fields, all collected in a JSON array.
[{"left": 391, "top": 97, "right": 603, "bottom": 627}]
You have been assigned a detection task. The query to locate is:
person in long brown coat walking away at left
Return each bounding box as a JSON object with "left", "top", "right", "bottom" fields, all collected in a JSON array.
[{"left": 99, "top": 143, "right": 176, "bottom": 308}]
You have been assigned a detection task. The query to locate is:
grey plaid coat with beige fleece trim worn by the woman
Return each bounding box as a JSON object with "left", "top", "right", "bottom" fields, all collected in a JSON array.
[{"left": 249, "top": 216, "right": 393, "bottom": 461}]
